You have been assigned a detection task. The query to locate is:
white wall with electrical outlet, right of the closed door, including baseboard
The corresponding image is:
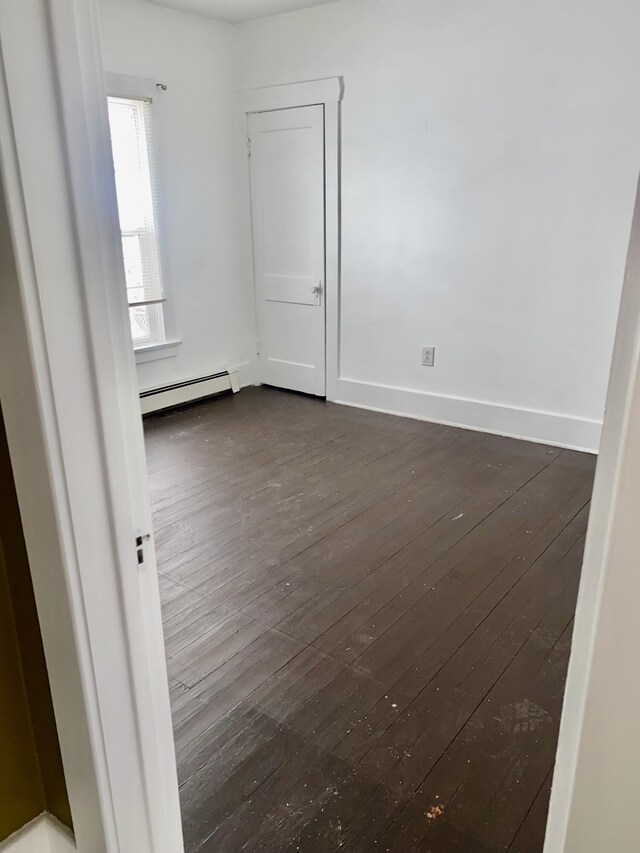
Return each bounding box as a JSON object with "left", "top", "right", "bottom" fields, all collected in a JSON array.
[{"left": 235, "top": 0, "right": 640, "bottom": 448}]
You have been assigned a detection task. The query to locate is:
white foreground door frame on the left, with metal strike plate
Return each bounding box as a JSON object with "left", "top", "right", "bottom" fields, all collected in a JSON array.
[{"left": 0, "top": 0, "right": 183, "bottom": 853}]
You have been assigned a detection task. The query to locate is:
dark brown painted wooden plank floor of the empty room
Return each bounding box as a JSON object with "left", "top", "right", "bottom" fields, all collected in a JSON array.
[{"left": 145, "top": 388, "right": 594, "bottom": 853}]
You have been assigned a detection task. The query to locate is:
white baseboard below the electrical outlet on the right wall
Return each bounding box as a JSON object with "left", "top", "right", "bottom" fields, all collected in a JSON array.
[{"left": 332, "top": 378, "right": 602, "bottom": 453}]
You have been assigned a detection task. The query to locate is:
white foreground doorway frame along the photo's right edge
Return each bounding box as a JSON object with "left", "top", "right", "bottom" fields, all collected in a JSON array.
[{"left": 544, "top": 178, "right": 640, "bottom": 853}]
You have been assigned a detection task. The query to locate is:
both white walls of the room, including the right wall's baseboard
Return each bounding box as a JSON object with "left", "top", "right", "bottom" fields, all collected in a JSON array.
[{"left": 101, "top": 0, "right": 640, "bottom": 449}]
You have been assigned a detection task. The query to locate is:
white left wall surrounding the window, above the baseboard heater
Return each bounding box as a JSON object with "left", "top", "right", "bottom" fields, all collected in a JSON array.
[{"left": 100, "top": 0, "right": 255, "bottom": 388}]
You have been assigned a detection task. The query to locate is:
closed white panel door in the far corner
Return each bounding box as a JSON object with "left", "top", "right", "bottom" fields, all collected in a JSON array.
[{"left": 249, "top": 106, "right": 325, "bottom": 396}]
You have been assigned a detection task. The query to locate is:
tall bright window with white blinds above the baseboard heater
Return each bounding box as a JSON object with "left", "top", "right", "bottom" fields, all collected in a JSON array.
[{"left": 108, "top": 97, "right": 165, "bottom": 347}]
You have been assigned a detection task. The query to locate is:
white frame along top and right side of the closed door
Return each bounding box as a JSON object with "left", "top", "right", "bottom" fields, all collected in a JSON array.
[{"left": 241, "top": 77, "right": 344, "bottom": 400}]
